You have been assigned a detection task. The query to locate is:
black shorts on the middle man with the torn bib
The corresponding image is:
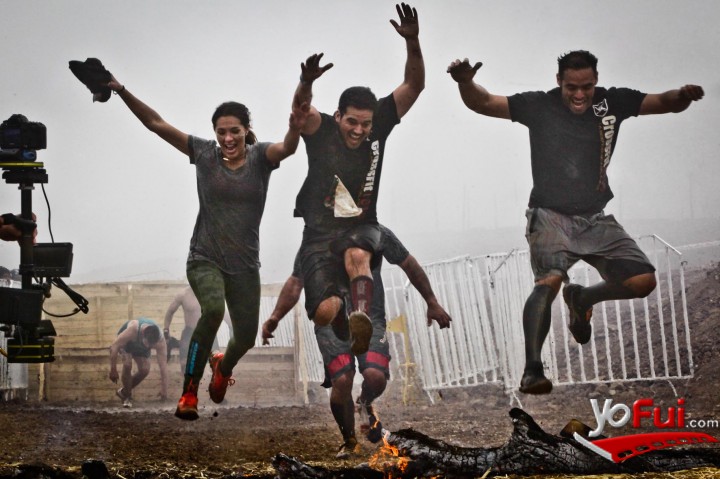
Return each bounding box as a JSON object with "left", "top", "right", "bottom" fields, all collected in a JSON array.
[{"left": 298, "top": 224, "right": 382, "bottom": 319}]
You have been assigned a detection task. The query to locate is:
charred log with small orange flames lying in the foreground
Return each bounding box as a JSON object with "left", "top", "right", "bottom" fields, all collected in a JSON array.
[{"left": 273, "top": 408, "right": 720, "bottom": 479}]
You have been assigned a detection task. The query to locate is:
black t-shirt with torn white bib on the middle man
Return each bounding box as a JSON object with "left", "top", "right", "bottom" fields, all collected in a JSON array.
[{"left": 295, "top": 94, "right": 400, "bottom": 233}]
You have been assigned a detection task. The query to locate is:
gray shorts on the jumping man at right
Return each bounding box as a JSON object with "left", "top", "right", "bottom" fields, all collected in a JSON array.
[{"left": 525, "top": 208, "right": 655, "bottom": 283}]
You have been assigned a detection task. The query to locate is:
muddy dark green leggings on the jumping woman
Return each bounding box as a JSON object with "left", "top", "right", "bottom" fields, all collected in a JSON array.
[{"left": 183, "top": 261, "right": 260, "bottom": 391}]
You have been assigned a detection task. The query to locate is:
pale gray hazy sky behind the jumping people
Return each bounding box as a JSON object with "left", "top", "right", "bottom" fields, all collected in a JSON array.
[{"left": 0, "top": 0, "right": 720, "bottom": 283}]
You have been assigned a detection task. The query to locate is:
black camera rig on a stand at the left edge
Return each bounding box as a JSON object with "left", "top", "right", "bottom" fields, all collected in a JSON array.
[{"left": 0, "top": 114, "right": 88, "bottom": 363}]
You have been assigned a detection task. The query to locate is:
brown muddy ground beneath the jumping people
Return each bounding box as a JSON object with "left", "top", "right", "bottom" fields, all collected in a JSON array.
[{"left": 0, "top": 264, "right": 720, "bottom": 478}]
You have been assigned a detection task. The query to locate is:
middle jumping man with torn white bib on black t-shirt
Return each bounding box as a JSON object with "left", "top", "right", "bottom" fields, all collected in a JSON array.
[{"left": 288, "top": 3, "right": 425, "bottom": 462}]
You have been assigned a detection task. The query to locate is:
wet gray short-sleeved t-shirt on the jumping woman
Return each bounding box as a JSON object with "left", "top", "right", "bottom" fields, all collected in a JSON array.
[{"left": 188, "top": 136, "right": 277, "bottom": 273}]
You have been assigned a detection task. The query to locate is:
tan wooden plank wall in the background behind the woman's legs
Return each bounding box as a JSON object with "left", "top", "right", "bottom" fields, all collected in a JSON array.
[{"left": 28, "top": 282, "right": 306, "bottom": 406}]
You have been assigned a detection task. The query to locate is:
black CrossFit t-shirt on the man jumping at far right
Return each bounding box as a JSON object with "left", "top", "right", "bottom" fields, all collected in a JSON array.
[{"left": 508, "top": 87, "right": 645, "bottom": 215}]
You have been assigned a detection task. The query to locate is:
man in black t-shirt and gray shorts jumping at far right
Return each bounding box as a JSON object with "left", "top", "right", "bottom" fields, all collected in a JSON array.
[{"left": 447, "top": 50, "right": 704, "bottom": 394}]
